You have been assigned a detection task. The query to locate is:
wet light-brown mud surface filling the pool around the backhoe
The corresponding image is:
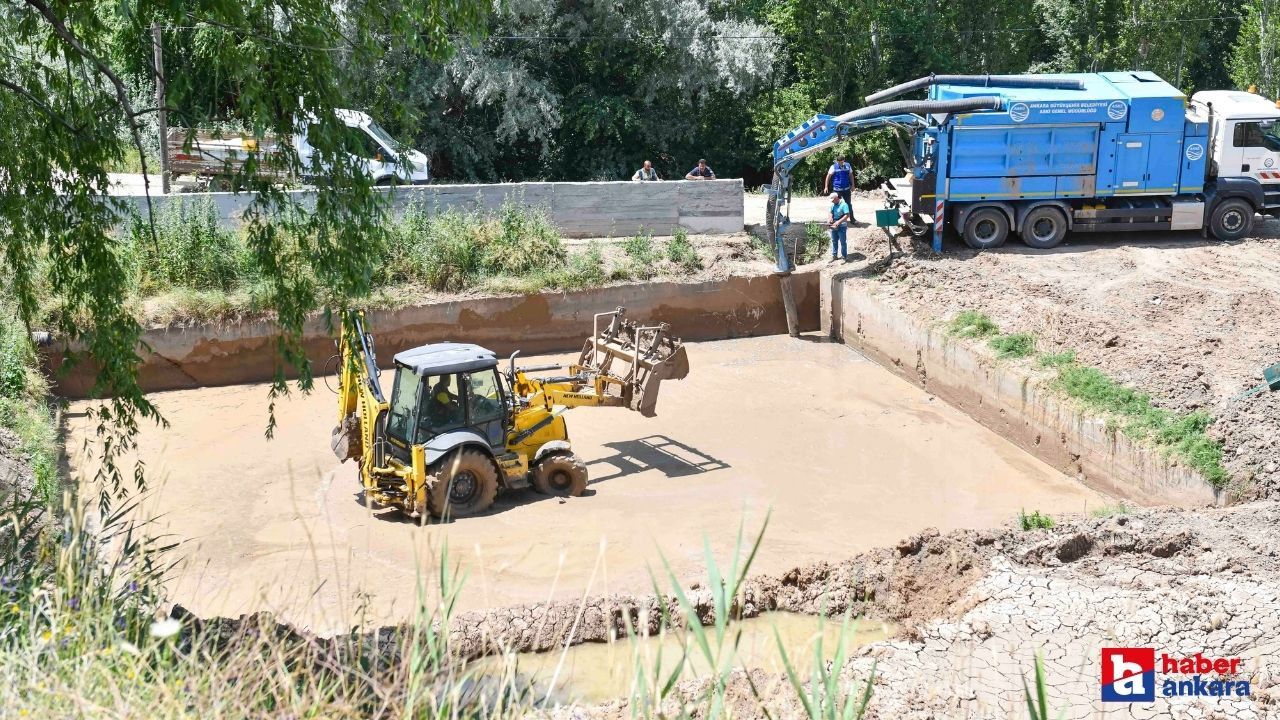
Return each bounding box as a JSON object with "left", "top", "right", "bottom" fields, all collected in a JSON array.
[{"left": 67, "top": 336, "right": 1106, "bottom": 633}]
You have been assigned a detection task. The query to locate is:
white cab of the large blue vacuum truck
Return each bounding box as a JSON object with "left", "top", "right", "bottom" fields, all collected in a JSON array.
[{"left": 1192, "top": 90, "right": 1280, "bottom": 186}]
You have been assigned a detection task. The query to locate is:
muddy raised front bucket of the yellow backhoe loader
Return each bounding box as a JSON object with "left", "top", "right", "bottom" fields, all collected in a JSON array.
[{"left": 577, "top": 307, "right": 689, "bottom": 418}]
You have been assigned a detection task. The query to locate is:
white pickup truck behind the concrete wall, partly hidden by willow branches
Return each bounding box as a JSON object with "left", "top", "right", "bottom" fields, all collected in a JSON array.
[{"left": 168, "top": 110, "right": 430, "bottom": 191}]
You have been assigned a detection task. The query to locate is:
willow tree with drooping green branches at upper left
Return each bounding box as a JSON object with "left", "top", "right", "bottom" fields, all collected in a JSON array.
[{"left": 0, "top": 0, "right": 488, "bottom": 504}]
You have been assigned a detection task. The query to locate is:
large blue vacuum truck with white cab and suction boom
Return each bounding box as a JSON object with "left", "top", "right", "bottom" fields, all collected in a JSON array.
[{"left": 771, "top": 72, "right": 1280, "bottom": 260}]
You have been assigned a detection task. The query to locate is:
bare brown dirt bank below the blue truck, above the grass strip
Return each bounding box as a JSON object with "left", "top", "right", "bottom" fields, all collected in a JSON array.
[{"left": 834, "top": 220, "right": 1280, "bottom": 498}]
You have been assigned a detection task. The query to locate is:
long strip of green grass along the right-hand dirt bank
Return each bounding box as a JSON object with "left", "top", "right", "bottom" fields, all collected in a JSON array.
[{"left": 1041, "top": 354, "right": 1230, "bottom": 487}]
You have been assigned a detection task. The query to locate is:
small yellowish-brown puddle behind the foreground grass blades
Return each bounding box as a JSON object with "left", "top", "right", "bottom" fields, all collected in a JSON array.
[{"left": 470, "top": 612, "right": 895, "bottom": 703}]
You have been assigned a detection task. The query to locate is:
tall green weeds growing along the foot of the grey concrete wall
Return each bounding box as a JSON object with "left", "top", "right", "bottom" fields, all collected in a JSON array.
[{"left": 108, "top": 196, "right": 721, "bottom": 323}]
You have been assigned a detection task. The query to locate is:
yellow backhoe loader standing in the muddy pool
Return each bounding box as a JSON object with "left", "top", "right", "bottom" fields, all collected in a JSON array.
[{"left": 332, "top": 307, "right": 689, "bottom": 519}]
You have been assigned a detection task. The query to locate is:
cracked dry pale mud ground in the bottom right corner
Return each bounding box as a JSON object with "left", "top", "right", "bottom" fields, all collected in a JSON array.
[{"left": 550, "top": 502, "right": 1280, "bottom": 719}]
